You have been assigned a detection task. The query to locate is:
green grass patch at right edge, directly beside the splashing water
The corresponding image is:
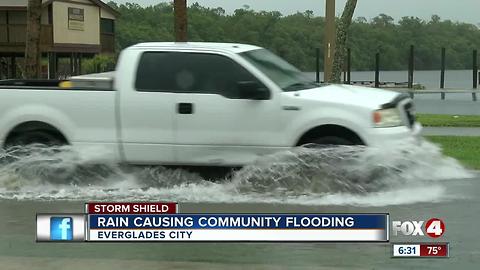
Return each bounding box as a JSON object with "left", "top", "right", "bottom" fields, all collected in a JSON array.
[{"left": 426, "top": 136, "right": 480, "bottom": 170}]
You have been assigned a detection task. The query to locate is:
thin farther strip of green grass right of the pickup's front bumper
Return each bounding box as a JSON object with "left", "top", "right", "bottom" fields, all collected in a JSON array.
[{"left": 417, "top": 114, "right": 480, "bottom": 127}]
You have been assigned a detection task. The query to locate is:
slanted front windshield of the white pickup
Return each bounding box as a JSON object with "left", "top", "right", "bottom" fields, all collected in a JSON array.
[{"left": 240, "top": 49, "right": 319, "bottom": 91}]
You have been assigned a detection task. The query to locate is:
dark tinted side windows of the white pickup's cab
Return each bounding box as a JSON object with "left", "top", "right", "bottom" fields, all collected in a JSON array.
[{"left": 135, "top": 52, "right": 265, "bottom": 99}]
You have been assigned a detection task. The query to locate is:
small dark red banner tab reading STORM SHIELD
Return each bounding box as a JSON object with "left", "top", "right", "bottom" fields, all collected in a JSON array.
[{"left": 85, "top": 202, "right": 177, "bottom": 214}]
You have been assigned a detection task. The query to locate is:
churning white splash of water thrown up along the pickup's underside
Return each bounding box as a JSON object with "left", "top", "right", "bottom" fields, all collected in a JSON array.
[{"left": 0, "top": 141, "right": 471, "bottom": 206}]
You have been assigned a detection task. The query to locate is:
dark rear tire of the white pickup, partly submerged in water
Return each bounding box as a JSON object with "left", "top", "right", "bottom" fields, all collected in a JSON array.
[{"left": 5, "top": 130, "right": 66, "bottom": 148}]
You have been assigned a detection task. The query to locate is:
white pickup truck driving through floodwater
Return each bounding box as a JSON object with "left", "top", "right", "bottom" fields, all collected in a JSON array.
[{"left": 0, "top": 43, "right": 421, "bottom": 166}]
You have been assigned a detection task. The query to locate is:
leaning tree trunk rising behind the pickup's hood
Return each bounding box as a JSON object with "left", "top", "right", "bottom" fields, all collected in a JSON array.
[{"left": 330, "top": 0, "right": 357, "bottom": 83}]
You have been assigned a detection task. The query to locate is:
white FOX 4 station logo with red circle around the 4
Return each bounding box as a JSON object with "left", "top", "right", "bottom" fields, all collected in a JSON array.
[{"left": 392, "top": 218, "right": 445, "bottom": 238}]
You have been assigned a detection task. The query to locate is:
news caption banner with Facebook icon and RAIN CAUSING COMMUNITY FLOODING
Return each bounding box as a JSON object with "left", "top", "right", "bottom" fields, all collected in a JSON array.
[{"left": 37, "top": 203, "right": 389, "bottom": 242}]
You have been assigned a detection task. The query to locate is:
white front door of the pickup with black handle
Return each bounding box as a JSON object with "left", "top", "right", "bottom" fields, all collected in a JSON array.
[{"left": 170, "top": 52, "right": 282, "bottom": 165}]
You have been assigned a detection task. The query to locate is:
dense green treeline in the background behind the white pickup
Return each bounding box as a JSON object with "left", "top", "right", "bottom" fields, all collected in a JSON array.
[{"left": 109, "top": 2, "right": 480, "bottom": 70}]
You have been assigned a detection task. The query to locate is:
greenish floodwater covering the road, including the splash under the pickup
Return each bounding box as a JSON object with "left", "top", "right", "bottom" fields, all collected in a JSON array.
[{"left": 0, "top": 142, "right": 480, "bottom": 269}]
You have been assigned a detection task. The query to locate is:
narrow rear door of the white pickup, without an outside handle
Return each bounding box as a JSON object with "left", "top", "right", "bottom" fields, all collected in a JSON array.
[{"left": 116, "top": 50, "right": 176, "bottom": 164}]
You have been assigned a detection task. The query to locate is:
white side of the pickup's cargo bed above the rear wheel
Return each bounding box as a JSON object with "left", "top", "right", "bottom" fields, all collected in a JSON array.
[{"left": 0, "top": 77, "right": 118, "bottom": 158}]
